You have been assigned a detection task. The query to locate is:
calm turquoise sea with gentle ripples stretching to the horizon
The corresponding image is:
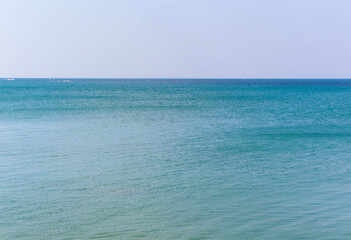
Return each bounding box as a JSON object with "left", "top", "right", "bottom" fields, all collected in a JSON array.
[{"left": 0, "top": 79, "right": 351, "bottom": 239}]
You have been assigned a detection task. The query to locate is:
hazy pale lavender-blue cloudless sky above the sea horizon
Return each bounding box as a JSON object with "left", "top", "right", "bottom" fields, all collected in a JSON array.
[{"left": 0, "top": 0, "right": 351, "bottom": 78}]
